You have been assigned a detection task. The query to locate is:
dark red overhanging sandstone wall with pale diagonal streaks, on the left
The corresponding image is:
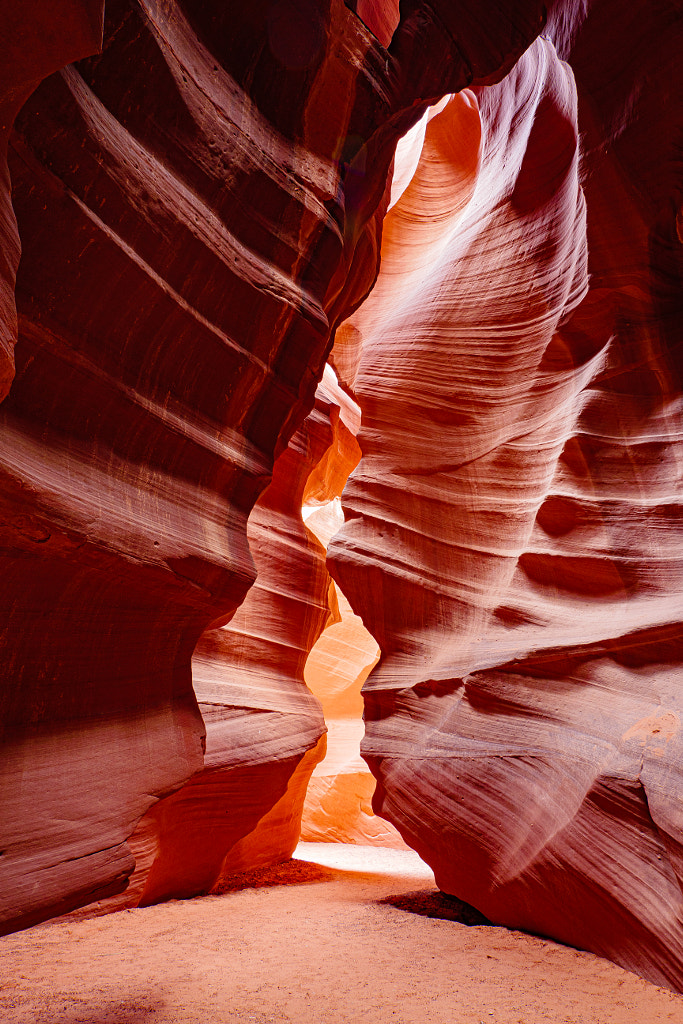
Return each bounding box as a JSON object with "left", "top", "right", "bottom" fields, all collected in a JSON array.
[{"left": 0, "top": 0, "right": 542, "bottom": 928}]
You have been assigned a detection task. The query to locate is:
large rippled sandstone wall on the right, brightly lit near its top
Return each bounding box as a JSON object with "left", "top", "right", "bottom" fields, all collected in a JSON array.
[{"left": 330, "top": 0, "right": 683, "bottom": 989}]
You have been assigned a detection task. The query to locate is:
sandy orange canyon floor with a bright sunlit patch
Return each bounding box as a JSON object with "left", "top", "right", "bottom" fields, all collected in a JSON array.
[{"left": 0, "top": 844, "right": 683, "bottom": 1024}]
